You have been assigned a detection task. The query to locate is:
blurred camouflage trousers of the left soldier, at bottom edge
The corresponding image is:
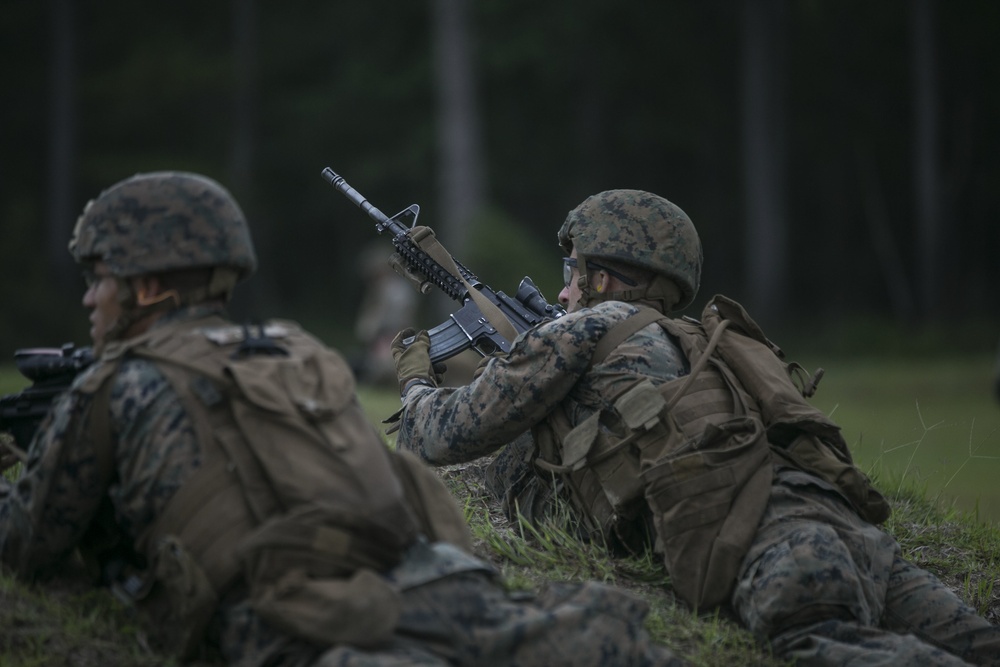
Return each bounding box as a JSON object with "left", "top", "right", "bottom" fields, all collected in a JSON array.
[{"left": 276, "top": 572, "right": 686, "bottom": 667}]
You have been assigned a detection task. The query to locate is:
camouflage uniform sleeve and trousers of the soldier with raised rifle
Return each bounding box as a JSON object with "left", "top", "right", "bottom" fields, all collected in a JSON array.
[{"left": 397, "top": 189, "right": 1000, "bottom": 665}]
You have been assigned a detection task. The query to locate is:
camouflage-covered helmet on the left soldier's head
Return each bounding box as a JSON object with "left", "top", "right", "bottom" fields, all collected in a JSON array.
[{"left": 69, "top": 171, "right": 257, "bottom": 280}]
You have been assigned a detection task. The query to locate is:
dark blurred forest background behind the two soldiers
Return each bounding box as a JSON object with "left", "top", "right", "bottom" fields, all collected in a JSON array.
[{"left": 0, "top": 0, "right": 1000, "bottom": 360}]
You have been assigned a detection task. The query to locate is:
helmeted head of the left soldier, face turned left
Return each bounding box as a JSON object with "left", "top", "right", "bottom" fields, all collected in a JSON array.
[{"left": 69, "top": 171, "right": 257, "bottom": 352}]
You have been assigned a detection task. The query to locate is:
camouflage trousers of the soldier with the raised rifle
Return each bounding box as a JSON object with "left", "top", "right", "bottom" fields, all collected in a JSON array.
[{"left": 733, "top": 471, "right": 1000, "bottom": 665}]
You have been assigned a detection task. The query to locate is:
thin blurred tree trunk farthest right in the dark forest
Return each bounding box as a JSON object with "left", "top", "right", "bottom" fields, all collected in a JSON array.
[{"left": 910, "top": 0, "right": 948, "bottom": 321}]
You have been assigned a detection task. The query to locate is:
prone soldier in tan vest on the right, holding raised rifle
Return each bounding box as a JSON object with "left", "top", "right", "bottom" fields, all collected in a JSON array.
[{"left": 394, "top": 190, "right": 1000, "bottom": 665}]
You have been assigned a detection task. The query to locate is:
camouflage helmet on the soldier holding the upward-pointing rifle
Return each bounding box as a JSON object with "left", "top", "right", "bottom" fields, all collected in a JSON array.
[{"left": 559, "top": 190, "right": 702, "bottom": 309}]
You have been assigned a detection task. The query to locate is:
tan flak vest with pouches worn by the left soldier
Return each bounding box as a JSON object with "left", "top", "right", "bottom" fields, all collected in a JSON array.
[{"left": 79, "top": 317, "right": 472, "bottom": 656}]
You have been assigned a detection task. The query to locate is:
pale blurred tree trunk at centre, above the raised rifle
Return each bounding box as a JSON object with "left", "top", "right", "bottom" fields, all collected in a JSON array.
[{"left": 432, "top": 0, "right": 484, "bottom": 315}]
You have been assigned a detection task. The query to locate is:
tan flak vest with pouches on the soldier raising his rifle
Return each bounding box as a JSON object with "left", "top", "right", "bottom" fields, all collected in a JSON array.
[{"left": 533, "top": 295, "right": 889, "bottom": 609}]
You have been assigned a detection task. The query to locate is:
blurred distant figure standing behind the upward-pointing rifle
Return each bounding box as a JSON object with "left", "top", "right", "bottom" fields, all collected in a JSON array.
[{"left": 354, "top": 245, "right": 417, "bottom": 385}]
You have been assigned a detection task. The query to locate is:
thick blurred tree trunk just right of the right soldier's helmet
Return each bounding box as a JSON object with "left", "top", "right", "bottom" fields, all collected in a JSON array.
[{"left": 743, "top": 0, "right": 788, "bottom": 321}]
